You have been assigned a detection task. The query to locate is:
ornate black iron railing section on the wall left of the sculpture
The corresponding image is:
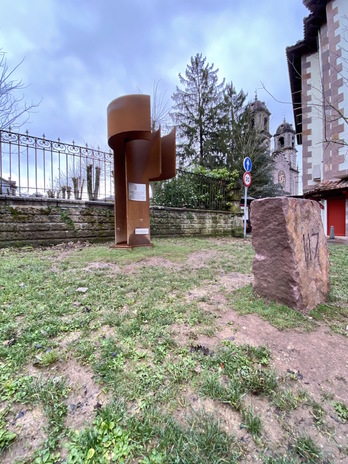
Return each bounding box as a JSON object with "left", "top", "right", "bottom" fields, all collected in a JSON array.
[{"left": 0, "top": 129, "right": 113, "bottom": 200}]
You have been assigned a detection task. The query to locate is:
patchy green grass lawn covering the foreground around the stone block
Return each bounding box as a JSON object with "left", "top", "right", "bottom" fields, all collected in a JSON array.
[{"left": 0, "top": 238, "right": 348, "bottom": 464}]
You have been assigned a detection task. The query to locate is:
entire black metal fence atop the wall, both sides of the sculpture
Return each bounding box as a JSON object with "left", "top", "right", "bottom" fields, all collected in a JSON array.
[{"left": 0, "top": 130, "right": 236, "bottom": 211}]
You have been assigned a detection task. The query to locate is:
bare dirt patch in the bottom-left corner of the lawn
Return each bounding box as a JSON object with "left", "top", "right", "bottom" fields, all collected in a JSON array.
[{"left": 1, "top": 405, "right": 47, "bottom": 464}]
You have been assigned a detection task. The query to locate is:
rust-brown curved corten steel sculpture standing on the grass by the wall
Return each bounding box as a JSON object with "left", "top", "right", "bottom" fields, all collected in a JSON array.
[{"left": 107, "top": 95, "right": 176, "bottom": 248}]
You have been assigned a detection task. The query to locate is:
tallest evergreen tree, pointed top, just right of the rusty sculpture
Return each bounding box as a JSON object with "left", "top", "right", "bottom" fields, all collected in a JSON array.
[{"left": 171, "top": 53, "right": 224, "bottom": 169}]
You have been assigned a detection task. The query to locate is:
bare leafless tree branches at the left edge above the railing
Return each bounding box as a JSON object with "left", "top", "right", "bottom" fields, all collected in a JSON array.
[{"left": 0, "top": 49, "right": 40, "bottom": 129}]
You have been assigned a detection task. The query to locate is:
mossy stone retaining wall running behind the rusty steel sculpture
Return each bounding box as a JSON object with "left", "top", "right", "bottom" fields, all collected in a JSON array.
[{"left": 0, "top": 195, "right": 243, "bottom": 247}]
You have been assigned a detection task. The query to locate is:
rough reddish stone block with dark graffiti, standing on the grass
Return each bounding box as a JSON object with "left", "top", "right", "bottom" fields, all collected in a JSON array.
[{"left": 251, "top": 197, "right": 330, "bottom": 313}]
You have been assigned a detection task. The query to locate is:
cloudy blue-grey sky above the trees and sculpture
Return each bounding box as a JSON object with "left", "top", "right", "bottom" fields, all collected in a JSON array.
[{"left": 0, "top": 0, "right": 308, "bottom": 152}]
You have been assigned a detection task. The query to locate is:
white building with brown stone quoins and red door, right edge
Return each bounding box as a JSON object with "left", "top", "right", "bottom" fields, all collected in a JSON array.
[{"left": 287, "top": 0, "right": 348, "bottom": 236}]
